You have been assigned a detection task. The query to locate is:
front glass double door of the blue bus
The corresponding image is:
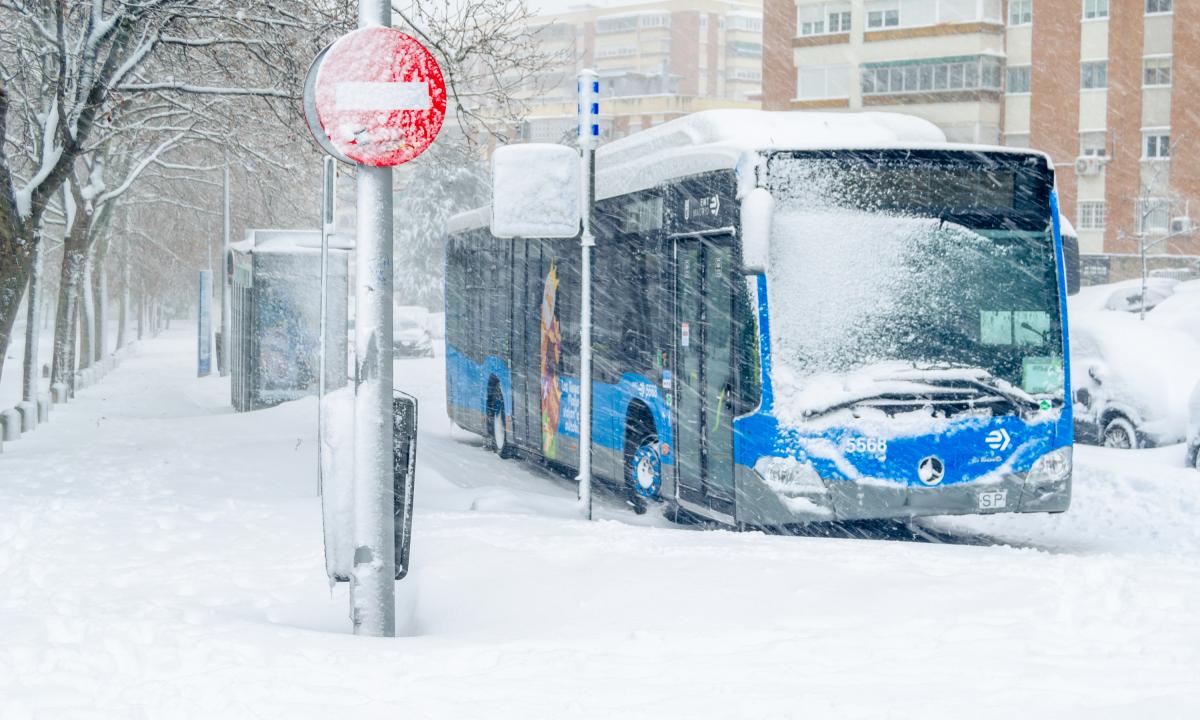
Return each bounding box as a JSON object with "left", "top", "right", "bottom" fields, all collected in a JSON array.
[{"left": 673, "top": 230, "right": 734, "bottom": 517}]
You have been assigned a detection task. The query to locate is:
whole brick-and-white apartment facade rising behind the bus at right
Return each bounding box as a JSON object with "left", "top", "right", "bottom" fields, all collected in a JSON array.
[{"left": 763, "top": 0, "right": 1200, "bottom": 264}]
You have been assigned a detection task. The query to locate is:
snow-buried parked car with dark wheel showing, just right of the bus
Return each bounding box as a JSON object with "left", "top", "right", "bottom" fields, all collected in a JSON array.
[{"left": 1070, "top": 311, "right": 1200, "bottom": 448}]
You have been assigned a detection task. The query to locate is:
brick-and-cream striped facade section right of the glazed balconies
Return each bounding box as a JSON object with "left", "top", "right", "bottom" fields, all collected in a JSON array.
[{"left": 1004, "top": 0, "right": 1200, "bottom": 261}]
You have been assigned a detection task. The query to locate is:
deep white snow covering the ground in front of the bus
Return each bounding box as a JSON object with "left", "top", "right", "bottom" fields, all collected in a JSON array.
[{"left": 0, "top": 330, "right": 1200, "bottom": 720}]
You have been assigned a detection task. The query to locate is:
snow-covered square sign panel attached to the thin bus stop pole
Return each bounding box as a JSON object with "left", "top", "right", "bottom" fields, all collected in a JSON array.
[{"left": 492, "top": 143, "right": 582, "bottom": 238}]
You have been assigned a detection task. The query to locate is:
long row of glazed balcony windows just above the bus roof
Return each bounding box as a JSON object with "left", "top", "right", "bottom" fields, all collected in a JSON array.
[{"left": 862, "top": 55, "right": 1001, "bottom": 95}]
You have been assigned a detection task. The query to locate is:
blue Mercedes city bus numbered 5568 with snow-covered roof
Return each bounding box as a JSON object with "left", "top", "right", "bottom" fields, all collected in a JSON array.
[{"left": 445, "top": 110, "right": 1072, "bottom": 528}]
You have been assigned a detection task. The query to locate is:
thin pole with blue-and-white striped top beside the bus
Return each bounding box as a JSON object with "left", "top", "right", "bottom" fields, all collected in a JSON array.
[{"left": 577, "top": 70, "right": 600, "bottom": 520}]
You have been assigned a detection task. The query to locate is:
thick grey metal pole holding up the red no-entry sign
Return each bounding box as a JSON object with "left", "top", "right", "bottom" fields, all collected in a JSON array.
[{"left": 350, "top": 0, "right": 396, "bottom": 637}]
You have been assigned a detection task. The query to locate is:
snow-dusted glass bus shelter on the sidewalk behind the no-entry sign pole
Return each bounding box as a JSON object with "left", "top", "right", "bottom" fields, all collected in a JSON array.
[{"left": 226, "top": 230, "right": 349, "bottom": 412}]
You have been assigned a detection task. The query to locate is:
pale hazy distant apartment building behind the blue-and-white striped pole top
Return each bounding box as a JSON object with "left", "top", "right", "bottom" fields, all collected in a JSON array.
[{"left": 521, "top": 0, "right": 762, "bottom": 142}]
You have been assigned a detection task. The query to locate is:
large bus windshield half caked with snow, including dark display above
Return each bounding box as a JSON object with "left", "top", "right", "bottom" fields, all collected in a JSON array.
[{"left": 768, "top": 151, "right": 1063, "bottom": 413}]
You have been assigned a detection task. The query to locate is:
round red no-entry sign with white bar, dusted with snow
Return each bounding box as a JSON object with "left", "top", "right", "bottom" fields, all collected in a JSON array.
[{"left": 312, "top": 28, "right": 446, "bottom": 167}]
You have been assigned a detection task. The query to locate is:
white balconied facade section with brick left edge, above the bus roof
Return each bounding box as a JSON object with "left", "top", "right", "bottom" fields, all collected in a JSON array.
[{"left": 763, "top": 0, "right": 1008, "bottom": 144}]
